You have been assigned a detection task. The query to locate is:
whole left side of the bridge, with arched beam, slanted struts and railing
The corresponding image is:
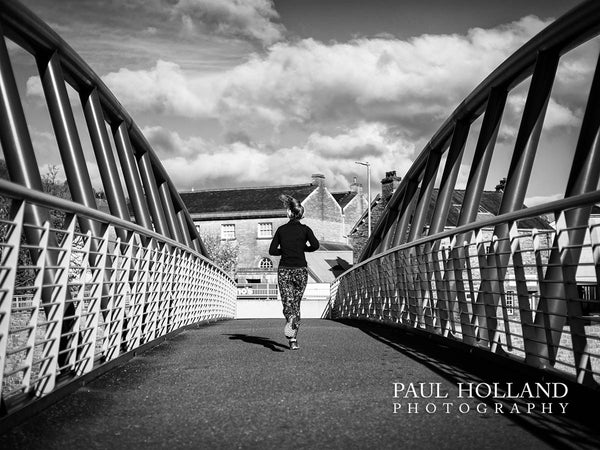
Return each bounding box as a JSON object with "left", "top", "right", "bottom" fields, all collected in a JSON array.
[{"left": 0, "top": 0, "right": 236, "bottom": 420}]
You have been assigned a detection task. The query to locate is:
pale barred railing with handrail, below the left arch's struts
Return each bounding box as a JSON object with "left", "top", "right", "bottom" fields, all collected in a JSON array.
[{"left": 0, "top": 180, "right": 237, "bottom": 412}]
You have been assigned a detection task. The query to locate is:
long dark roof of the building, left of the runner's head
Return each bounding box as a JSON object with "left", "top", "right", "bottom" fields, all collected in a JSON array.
[{"left": 179, "top": 184, "right": 316, "bottom": 214}]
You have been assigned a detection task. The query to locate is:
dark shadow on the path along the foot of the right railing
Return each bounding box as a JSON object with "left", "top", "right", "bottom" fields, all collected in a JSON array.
[{"left": 339, "top": 320, "right": 600, "bottom": 449}]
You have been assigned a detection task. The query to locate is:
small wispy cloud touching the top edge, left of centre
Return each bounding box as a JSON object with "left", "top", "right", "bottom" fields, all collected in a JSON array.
[{"left": 166, "top": 0, "right": 285, "bottom": 46}]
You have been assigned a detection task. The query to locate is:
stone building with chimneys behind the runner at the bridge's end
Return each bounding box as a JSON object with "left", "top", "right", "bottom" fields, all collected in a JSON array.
[{"left": 180, "top": 174, "right": 367, "bottom": 284}]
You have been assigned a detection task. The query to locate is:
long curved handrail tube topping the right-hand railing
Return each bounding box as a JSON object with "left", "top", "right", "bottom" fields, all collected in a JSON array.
[{"left": 337, "top": 191, "right": 600, "bottom": 279}]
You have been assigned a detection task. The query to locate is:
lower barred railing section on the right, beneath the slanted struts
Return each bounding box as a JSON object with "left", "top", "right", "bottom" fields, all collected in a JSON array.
[{"left": 331, "top": 192, "right": 600, "bottom": 385}]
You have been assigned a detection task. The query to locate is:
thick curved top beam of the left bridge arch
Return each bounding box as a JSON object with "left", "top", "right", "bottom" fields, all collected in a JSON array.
[{"left": 0, "top": 0, "right": 208, "bottom": 254}]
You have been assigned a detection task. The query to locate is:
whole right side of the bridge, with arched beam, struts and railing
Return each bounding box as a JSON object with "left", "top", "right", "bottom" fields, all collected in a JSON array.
[{"left": 332, "top": 1, "right": 600, "bottom": 386}]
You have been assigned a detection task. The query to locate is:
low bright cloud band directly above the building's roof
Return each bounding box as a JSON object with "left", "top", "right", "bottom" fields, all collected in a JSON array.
[{"left": 144, "top": 124, "right": 414, "bottom": 190}]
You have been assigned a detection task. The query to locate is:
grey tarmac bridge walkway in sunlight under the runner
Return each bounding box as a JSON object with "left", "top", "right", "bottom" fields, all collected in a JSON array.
[{"left": 0, "top": 319, "right": 600, "bottom": 449}]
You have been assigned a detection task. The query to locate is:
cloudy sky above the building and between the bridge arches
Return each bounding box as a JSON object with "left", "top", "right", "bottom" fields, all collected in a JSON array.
[{"left": 9, "top": 0, "right": 598, "bottom": 202}]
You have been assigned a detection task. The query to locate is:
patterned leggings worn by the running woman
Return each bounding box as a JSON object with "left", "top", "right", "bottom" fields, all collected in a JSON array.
[{"left": 277, "top": 267, "right": 308, "bottom": 338}]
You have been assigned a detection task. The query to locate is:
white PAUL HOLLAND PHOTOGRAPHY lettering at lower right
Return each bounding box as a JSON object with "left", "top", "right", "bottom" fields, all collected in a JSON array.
[{"left": 393, "top": 382, "right": 569, "bottom": 414}]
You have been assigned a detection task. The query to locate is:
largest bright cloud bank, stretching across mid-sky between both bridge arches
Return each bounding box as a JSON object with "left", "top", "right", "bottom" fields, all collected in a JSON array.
[{"left": 104, "top": 15, "right": 547, "bottom": 144}]
